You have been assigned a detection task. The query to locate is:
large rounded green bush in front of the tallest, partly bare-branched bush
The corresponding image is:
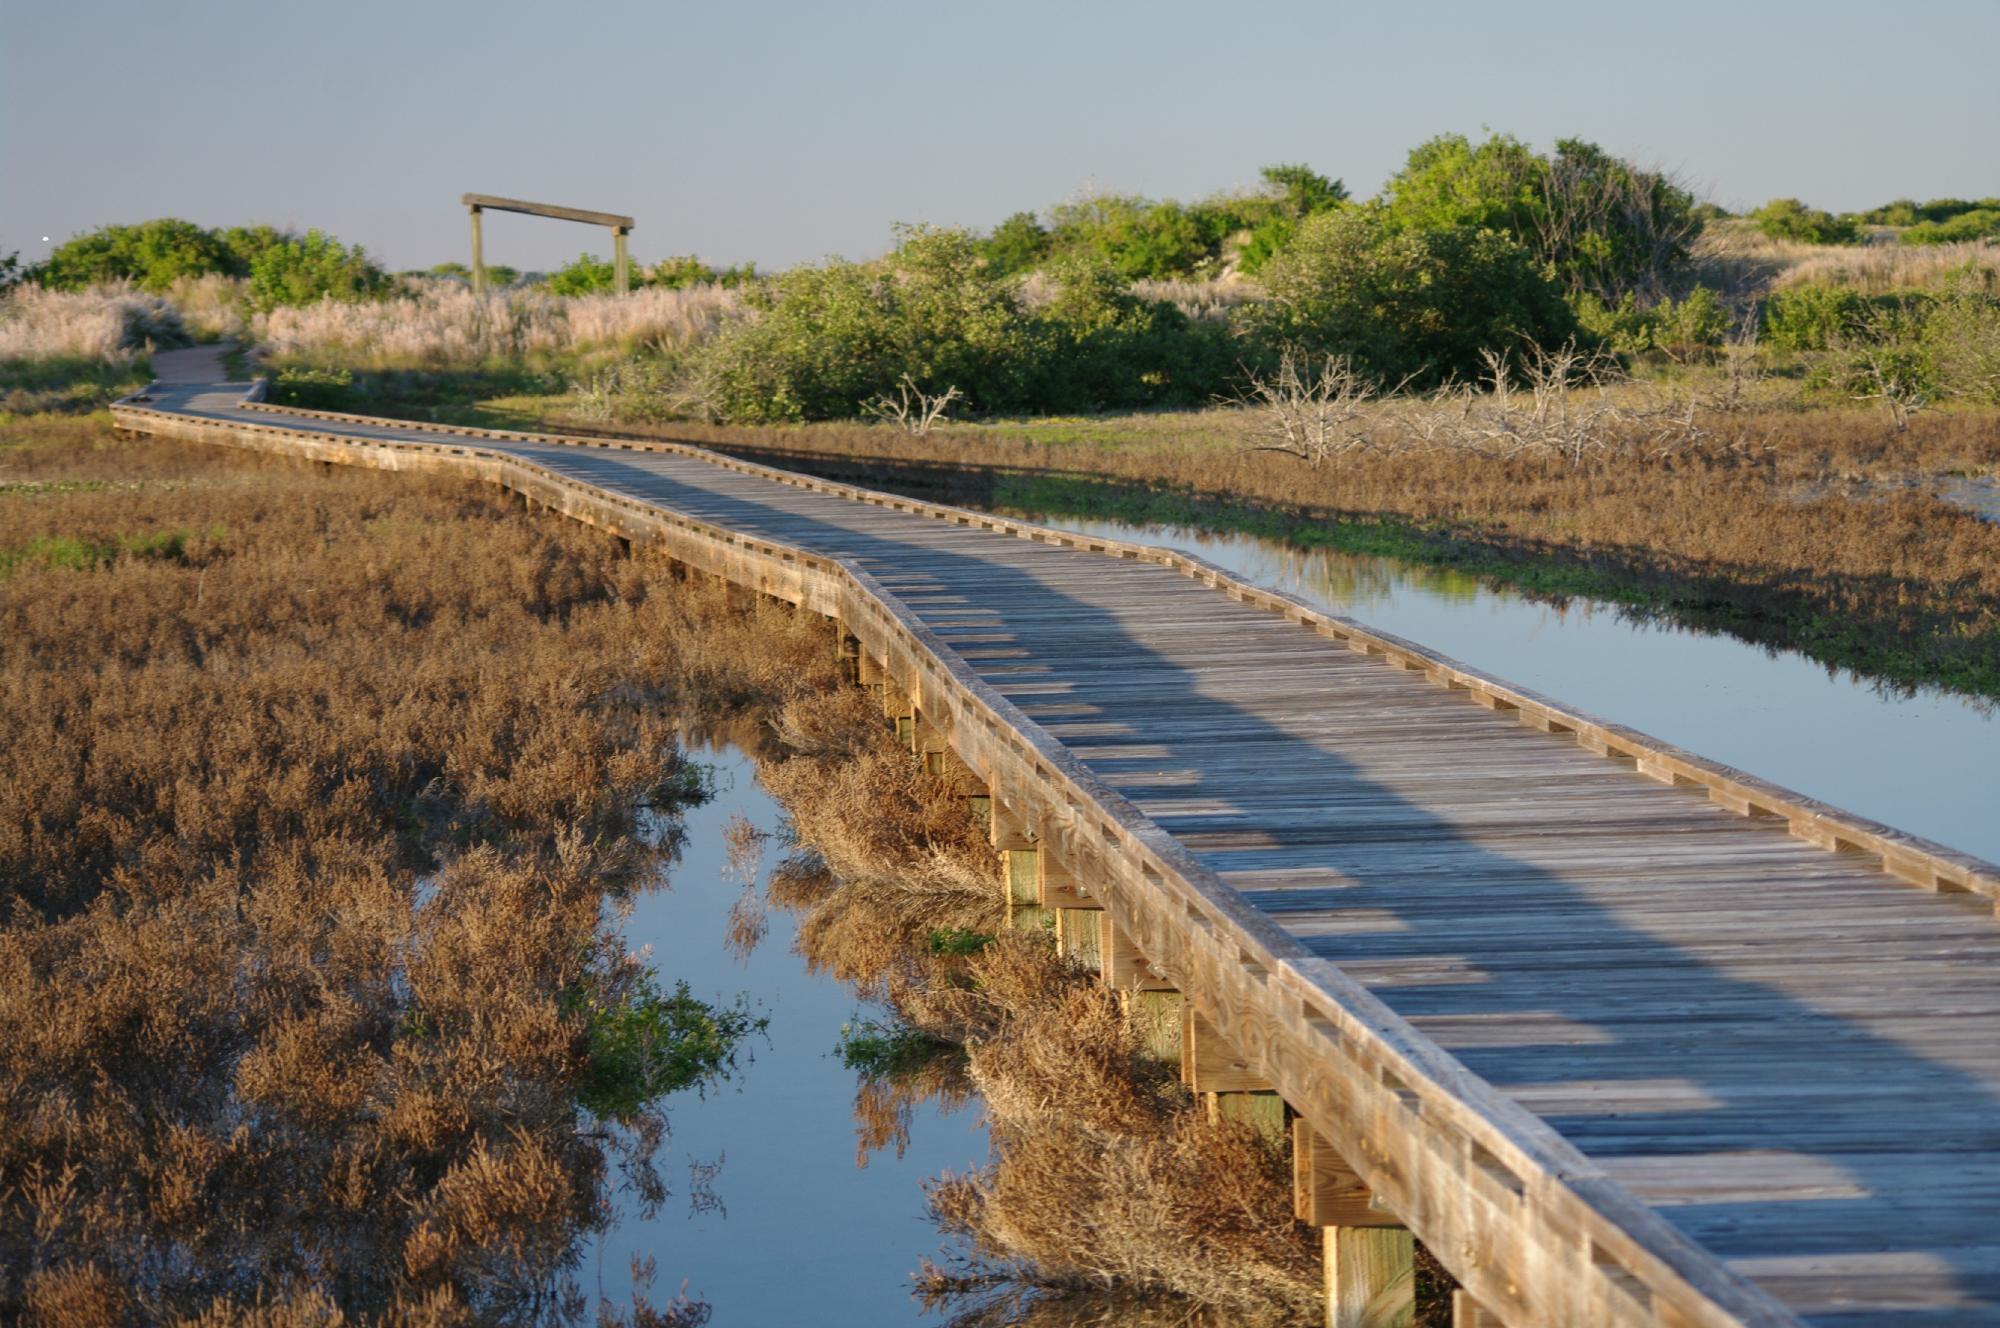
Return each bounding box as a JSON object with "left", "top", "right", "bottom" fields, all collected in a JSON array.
[{"left": 1244, "top": 208, "right": 1580, "bottom": 386}]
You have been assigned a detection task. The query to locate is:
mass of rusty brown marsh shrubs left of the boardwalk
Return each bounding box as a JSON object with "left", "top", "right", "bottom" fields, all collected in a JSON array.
[{"left": 0, "top": 420, "right": 834, "bottom": 1324}]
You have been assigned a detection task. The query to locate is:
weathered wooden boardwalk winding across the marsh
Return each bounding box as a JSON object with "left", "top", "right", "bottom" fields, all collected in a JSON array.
[{"left": 120, "top": 384, "right": 2000, "bottom": 1326}]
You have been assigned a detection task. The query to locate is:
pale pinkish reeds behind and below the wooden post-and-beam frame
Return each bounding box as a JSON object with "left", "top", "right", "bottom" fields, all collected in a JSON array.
[{"left": 252, "top": 278, "right": 742, "bottom": 370}]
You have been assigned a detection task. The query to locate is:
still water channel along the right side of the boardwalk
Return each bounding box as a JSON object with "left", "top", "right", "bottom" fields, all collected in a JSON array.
[{"left": 1018, "top": 512, "right": 2000, "bottom": 862}]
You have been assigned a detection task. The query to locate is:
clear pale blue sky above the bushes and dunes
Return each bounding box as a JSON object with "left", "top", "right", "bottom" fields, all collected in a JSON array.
[{"left": 0, "top": 0, "right": 2000, "bottom": 268}]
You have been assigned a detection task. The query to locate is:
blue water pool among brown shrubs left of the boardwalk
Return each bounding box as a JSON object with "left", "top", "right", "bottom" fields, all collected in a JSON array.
[{"left": 580, "top": 744, "right": 986, "bottom": 1326}]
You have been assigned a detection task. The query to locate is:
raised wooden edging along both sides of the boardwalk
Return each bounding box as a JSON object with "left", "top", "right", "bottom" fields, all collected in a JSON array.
[{"left": 112, "top": 376, "right": 2000, "bottom": 1328}]
